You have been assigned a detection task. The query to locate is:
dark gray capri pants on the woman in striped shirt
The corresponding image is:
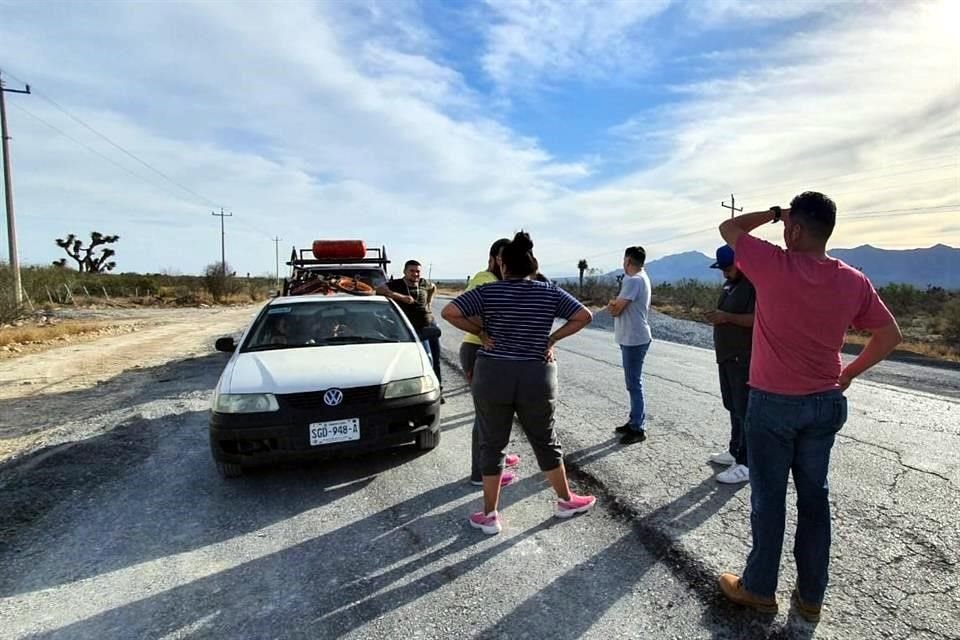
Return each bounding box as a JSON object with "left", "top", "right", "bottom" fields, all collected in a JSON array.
[{"left": 473, "top": 355, "right": 563, "bottom": 476}]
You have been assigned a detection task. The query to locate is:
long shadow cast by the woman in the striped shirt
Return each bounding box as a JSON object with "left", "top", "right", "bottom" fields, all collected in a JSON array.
[{"left": 20, "top": 477, "right": 555, "bottom": 638}]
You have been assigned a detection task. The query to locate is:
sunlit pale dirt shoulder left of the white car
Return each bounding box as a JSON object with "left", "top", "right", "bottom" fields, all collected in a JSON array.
[{"left": 0, "top": 305, "right": 259, "bottom": 464}]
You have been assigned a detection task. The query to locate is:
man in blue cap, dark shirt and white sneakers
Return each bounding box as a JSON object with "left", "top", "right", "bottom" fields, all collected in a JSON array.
[{"left": 707, "top": 245, "right": 757, "bottom": 484}]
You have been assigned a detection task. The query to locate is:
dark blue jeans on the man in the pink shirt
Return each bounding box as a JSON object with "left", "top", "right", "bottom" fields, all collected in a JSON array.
[{"left": 743, "top": 389, "right": 847, "bottom": 604}]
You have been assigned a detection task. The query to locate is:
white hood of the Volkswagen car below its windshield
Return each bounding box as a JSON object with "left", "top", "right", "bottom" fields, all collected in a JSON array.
[{"left": 219, "top": 342, "right": 432, "bottom": 393}]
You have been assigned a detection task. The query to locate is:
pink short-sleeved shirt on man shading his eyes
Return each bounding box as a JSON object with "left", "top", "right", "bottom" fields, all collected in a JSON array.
[{"left": 735, "top": 234, "right": 893, "bottom": 396}]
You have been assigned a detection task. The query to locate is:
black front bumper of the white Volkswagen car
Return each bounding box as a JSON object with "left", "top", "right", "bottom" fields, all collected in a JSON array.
[{"left": 210, "top": 391, "right": 440, "bottom": 465}]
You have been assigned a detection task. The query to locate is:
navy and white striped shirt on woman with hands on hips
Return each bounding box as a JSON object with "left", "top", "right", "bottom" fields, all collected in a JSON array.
[{"left": 453, "top": 280, "right": 584, "bottom": 360}]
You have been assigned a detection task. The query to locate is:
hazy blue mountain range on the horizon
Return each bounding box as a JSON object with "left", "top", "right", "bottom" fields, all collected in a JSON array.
[{"left": 584, "top": 244, "right": 960, "bottom": 289}]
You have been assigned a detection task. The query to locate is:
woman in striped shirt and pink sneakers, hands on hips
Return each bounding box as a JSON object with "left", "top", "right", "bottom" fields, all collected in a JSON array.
[{"left": 442, "top": 231, "right": 596, "bottom": 534}]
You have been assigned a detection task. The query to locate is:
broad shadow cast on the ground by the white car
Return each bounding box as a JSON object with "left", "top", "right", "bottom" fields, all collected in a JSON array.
[{"left": 0, "top": 354, "right": 436, "bottom": 597}]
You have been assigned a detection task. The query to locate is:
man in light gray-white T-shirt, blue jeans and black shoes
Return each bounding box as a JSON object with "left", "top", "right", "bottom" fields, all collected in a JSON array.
[{"left": 607, "top": 247, "right": 653, "bottom": 444}]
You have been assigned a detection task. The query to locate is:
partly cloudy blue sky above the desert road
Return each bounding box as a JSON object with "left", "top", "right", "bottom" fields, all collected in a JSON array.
[{"left": 0, "top": 0, "right": 960, "bottom": 277}]
